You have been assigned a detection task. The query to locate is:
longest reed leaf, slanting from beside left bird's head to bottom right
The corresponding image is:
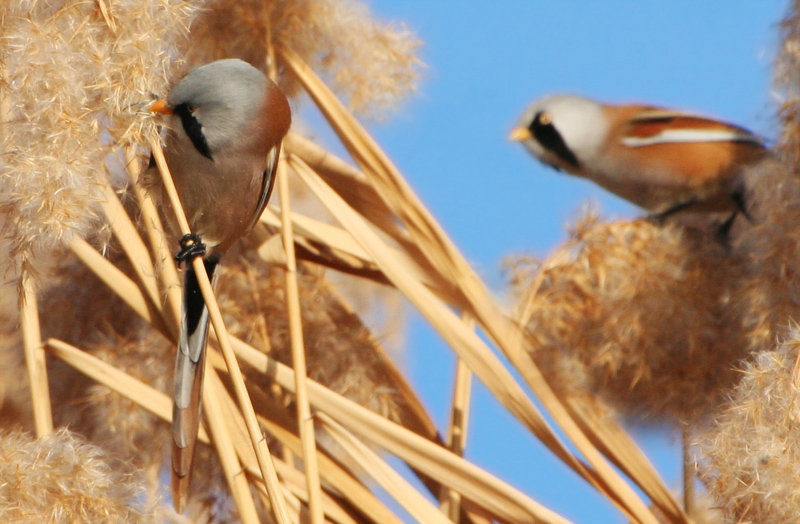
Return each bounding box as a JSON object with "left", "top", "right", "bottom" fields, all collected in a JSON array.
[{"left": 281, "top": 49, "right": 684, "bottom": 522}]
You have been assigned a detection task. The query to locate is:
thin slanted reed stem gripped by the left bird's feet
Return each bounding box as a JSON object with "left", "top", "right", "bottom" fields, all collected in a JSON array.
[{"left": 149, "top": 137, "right": 291, "bottom": 524}]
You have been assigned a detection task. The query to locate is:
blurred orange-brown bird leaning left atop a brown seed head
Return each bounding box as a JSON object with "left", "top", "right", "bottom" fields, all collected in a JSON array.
[{"left": 509, "top": 95, "right": 767, "bottom": 230}]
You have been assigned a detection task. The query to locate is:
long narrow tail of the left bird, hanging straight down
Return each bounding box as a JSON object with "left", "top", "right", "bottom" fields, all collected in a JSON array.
[{"left": 172, "top": 257, "right": 219, "bottom": 513}]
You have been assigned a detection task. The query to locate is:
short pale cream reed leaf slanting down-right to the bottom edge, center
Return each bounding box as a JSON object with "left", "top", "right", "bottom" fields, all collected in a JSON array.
[{"left": 318, "top": 413, "right": 460, "bottom": 524}]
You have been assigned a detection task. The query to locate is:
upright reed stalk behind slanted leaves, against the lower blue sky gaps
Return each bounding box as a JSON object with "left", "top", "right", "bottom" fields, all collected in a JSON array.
[{"left": 439, "top": 313, "right": 475, "bottom": 522}]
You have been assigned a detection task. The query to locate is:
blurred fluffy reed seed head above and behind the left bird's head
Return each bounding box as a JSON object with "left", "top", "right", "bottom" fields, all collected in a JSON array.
[{"left": 186, "top": 0, "right": 421, "bottom": 116}]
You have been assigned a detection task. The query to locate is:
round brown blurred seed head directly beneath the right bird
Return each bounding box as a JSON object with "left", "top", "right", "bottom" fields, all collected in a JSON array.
[{"left": 512, "top": 216, "right": 746, "bottom": 422}]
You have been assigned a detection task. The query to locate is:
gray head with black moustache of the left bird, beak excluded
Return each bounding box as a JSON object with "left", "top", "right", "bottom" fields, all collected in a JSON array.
[{"left": 167, "top": 59, "right": 268, "bottom": 160}]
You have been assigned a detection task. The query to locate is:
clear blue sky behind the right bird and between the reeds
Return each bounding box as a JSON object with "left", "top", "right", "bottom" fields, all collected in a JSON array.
[{"left": 318, "top": 0, "right": 788, "bottom": 523}]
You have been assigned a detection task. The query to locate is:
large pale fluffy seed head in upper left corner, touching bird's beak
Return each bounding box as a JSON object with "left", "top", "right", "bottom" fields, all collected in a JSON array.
[{"left": 0, "top": 0, "right": 193, "bottom": 276}]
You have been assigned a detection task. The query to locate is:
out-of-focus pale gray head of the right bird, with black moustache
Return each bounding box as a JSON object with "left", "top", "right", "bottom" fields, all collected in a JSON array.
[{"left": 510, "top": 95, "right": 608, "bottom": 173}]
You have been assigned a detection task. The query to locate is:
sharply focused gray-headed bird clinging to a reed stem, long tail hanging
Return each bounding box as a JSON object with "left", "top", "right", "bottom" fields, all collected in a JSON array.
[{"left": 145, "top": 59, "right": 291, "bottom": 512}]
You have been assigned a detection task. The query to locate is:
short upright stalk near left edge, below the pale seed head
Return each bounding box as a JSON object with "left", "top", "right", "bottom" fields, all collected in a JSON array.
[{"left": 19, "top": 268, "right": 53, "bottom": 438}]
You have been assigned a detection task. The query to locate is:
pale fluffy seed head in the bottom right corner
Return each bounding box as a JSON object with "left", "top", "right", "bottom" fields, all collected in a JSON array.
[{"left": 698, "top": 334, "right": 800, "bottom": 524}]
